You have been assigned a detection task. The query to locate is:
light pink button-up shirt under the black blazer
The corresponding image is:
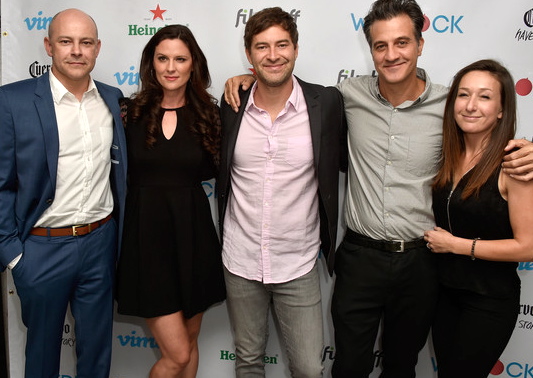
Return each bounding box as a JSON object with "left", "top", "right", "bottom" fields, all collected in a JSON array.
[{"left": 222, "top": 77, "right": 320, "bottom": 284}]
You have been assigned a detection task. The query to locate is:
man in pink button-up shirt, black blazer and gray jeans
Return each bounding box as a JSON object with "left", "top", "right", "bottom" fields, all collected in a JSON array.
[{"left": 218, "top": 8, "right": 346, "bottom": 378}]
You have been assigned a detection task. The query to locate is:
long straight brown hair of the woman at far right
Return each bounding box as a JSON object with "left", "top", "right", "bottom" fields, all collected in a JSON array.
[{"left": 433, "top": 59, "right": 516, "bottom": 199}]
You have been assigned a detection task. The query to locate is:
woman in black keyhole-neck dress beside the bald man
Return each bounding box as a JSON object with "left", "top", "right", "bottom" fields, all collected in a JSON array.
[{"left": 117, "top": 25, "right": 225, "bottom": 378}]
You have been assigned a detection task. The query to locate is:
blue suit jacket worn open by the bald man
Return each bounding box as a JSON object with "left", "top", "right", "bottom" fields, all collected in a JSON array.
[{"left": 0, "top": 74, "right": 127, "bottom": 270}]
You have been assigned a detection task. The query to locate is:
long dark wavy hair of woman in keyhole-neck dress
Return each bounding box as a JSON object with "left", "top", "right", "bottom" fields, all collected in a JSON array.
[{"left": 128, "top": 25, "right": 221, "bottom": 166}]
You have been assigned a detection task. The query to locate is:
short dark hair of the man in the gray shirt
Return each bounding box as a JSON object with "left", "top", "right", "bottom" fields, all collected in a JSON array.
[{"left": 363, "top": 0, "right": 424, "bottom": 48}]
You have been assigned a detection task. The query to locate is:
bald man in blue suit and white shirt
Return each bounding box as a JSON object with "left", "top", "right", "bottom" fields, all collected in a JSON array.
[{"left": 0, "top": 9, "right": 127, "bottom": 378}]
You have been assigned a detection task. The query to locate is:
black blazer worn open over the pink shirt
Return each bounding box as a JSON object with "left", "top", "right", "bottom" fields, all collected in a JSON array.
[{"left": 217, "top": 78, "right": 347, "bottom": 274}]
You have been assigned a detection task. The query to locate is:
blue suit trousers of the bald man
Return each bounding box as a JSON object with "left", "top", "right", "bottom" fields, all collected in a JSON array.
[{"left": 12, "top": 219, "right": 117, "bottom": 378}]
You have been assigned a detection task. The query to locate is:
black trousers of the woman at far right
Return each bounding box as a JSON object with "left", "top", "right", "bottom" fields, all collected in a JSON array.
[{"left": 432, "top": 286, "right": 520, "bottom": 378}]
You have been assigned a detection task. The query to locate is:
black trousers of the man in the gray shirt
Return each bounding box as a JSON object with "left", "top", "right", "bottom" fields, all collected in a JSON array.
[{"left": 332, "top": 235, "right": 438, "bottom": 378}]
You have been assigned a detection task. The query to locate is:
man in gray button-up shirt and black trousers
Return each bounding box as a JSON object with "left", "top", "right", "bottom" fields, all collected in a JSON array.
[{"left": 332, "top": 0, "right": 442, "bottom": 378}]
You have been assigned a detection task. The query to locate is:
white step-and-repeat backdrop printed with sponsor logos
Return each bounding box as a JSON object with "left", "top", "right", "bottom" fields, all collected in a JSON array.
[{"left": 0, "top": 0, "right": 533, "bottom": 378}]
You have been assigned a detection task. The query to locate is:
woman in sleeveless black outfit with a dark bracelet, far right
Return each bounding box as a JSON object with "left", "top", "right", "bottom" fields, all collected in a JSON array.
[{"left": 425, "top": 60, "right": 533, "bottom": 378}]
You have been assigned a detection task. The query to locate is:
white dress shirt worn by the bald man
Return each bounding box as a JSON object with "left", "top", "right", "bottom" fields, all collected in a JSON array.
[{"left": 35, "top": 72, "right": 113, "bottom": 227}]
